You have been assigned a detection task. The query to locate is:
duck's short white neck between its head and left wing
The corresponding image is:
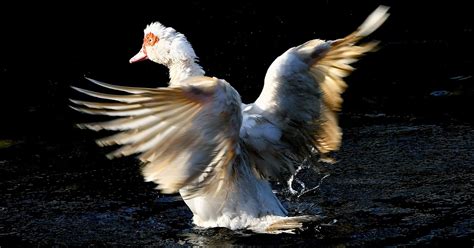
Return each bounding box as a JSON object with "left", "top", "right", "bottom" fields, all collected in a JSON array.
[{"left": 168, "top": 60, "right": 204, "bottom": 86}]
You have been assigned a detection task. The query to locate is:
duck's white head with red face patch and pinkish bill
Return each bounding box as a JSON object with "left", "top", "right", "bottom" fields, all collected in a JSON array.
[{"left": 130, "top": 22, "right": 196, "bottom": 66}]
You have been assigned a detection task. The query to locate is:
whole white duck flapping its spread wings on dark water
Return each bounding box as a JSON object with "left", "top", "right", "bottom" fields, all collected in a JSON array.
[{"left": 72, "top": 6, "right": 388, "bottom": 233}]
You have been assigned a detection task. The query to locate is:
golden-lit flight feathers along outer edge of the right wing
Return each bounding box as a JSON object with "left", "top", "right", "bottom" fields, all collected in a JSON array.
[{"left": 310, "top": 6, "right": 388, "bottom": 154}]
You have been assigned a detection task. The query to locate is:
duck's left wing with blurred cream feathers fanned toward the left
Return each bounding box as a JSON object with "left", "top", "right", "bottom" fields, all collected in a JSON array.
[{"left": 71, "top": 77, "right": 242, "bottom": 196}]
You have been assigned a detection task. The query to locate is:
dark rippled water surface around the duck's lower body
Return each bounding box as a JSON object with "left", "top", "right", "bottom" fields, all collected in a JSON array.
[{"left": 0, "top": 116, "right": 474, "bottom": 247}]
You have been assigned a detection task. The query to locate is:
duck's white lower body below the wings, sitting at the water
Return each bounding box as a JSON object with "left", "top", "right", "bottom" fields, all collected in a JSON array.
[{"left": 180, "top": 158, "right": 287, "bottom": 232}]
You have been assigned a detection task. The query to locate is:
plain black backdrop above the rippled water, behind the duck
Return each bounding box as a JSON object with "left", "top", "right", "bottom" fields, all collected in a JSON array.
[{"left": 0, "top": 0, "right": 473, "bottom": 141}]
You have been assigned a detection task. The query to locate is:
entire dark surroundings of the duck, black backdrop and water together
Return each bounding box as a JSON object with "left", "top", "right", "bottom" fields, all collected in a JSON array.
[{"left": 0, "top": 0, "right": 474, "bottom": 247}]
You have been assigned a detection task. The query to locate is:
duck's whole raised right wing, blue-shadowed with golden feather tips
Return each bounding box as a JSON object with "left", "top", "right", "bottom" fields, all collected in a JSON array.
[{"left": 240, "top": 6, "right": 388, "bottom": 177}]
